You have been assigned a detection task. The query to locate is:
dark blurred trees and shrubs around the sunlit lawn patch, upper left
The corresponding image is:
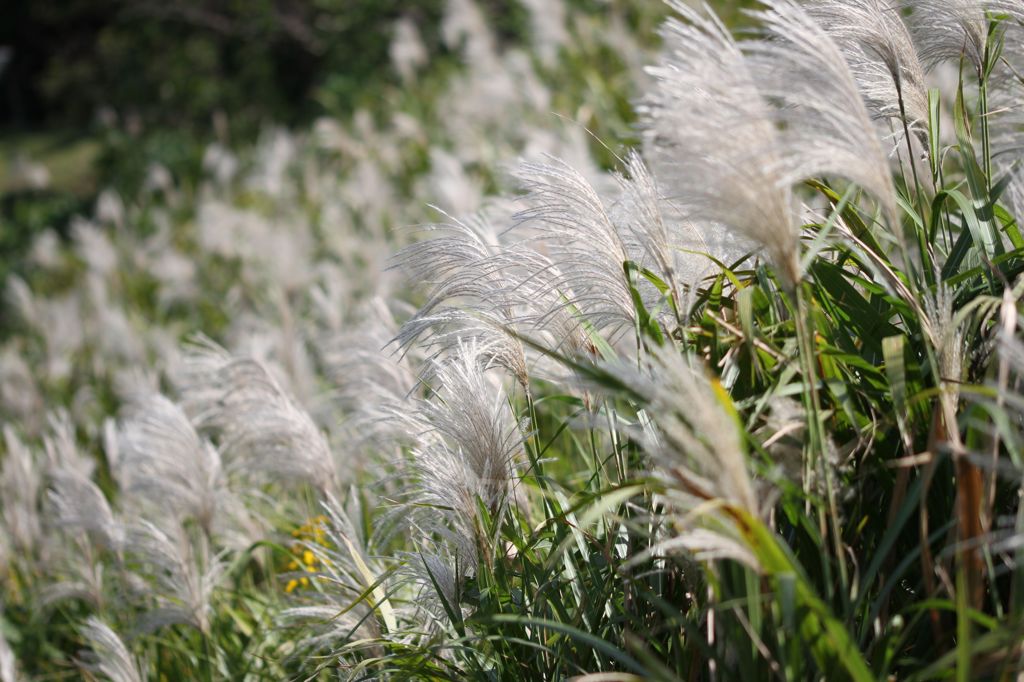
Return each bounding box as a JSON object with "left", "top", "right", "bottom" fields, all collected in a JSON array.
[{"left": 0, "top": 0, "right": 544, "bottom": 200}]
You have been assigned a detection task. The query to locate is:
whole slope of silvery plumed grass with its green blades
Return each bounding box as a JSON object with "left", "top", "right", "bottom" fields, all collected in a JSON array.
[{"left": 0, "top": 0, "right": 1024, "bottom": 682}]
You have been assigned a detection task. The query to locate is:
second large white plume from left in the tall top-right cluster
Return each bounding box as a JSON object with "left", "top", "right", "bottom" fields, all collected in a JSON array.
[{"left": 742, "top": 0, "right": 899, "bottom": 228}]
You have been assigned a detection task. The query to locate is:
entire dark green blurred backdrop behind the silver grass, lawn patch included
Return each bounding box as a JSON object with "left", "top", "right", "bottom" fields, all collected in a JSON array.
[{"left": 0, "top": 0, "right": 757, "bottom": 296}]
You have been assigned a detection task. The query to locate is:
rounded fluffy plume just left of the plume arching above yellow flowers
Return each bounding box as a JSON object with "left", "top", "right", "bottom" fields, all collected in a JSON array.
[{"left": 116, "top": 394, "right": 229, "bottom": 534}]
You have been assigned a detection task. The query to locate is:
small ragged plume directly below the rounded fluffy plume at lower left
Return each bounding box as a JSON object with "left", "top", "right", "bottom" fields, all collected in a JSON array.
[{"left": 128, "top": 520, "right": 227, "bottom": 633}]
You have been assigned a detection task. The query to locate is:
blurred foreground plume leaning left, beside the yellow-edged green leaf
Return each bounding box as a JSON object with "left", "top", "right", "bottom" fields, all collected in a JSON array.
[{"left": 607, "top": 345, "right": 762, "bottom": 567}]
